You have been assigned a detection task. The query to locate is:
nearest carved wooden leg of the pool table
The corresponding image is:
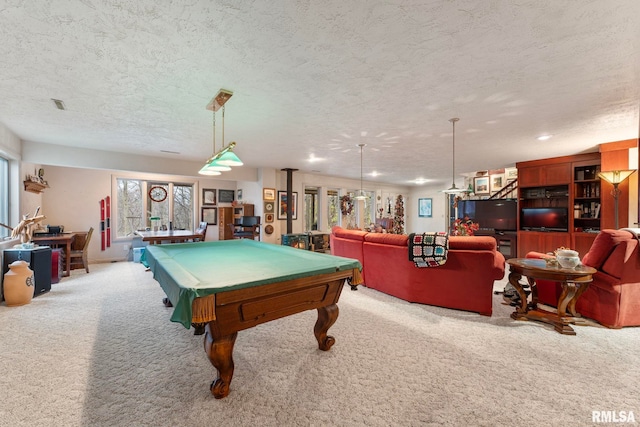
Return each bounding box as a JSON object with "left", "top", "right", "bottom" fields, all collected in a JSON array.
[{"left": 204, "top": 321, "right": 238, "bottom": 399}]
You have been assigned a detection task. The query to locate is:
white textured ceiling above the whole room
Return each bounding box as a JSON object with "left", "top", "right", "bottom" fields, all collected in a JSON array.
[{"left": 0, "top": 0, "right": 640, "bottom": 185}]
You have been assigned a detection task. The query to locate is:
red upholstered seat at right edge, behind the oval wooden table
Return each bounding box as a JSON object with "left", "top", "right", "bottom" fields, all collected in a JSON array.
[{"left": 526, "top": 229, "right": 640, "bottom": 328}]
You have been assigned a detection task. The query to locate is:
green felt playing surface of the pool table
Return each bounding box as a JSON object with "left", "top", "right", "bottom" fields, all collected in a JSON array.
[{"left": 145, "top": 239, "right": 362, "bottom": 328}]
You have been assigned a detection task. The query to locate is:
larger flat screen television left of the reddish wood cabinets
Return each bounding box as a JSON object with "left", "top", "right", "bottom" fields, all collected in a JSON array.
[{"left": 458, "top": 199, "right": 518, "bottom": 231}]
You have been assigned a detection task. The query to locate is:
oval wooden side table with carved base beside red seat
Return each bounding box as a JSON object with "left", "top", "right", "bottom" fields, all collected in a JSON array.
[{"left": 507, "top": 258, "right": 596, "bottom": 335}]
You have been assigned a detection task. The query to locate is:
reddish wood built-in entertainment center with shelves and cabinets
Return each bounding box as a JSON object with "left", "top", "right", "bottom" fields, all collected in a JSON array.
[{"left": 516, "top": 140, "right": 637, "bottom": 257}]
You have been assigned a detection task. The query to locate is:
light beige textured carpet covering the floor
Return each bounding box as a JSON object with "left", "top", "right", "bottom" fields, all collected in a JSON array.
[{"left": 0, "top": 262, "right": 640, "bottom": 427}]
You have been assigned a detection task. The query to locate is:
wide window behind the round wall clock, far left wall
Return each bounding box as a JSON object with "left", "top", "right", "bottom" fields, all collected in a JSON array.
[{"left": 116, "top": 178, "right": 195, "bottom": 237}]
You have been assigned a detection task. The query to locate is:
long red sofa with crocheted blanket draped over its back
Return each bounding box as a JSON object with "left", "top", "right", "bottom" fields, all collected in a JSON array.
[{"left": 330, "top": 226, "right": 505, "bottom": 316}]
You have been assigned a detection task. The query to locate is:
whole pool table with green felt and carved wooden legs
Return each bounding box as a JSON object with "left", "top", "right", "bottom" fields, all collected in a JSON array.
[{"left": 145, "top": 239, "right": 362, "bottom": 399}]
